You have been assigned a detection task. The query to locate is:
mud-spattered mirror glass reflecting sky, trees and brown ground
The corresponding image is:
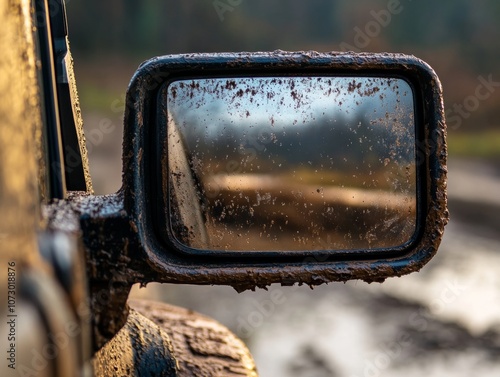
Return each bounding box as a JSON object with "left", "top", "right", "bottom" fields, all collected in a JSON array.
[{"left": 163, "top": 77, "right": 417, "bottom": 252}]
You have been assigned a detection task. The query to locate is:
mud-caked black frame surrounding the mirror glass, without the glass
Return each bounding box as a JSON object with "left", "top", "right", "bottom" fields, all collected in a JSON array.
[{"left": 121, "top": 51, "right": 448, "bottom": 291}]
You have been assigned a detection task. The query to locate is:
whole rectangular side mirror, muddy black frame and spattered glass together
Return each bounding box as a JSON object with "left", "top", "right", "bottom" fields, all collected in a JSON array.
[{"left": 116, "top": 52, "right": 448, "bottom": 290}]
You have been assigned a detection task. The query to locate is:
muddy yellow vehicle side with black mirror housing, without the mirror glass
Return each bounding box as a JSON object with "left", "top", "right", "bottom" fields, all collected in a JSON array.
[{"left": 0, "top": 0, "right": 447, "bottom": 376}]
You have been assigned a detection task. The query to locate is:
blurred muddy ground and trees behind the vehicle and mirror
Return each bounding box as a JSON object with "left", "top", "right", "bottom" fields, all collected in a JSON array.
[{"left": 67, "top": 0, "right": 500, "bottom": 377}]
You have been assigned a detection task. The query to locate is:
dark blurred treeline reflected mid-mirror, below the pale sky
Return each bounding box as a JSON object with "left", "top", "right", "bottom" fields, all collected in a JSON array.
[{"left": 184, "top": 109, "right": 415, "bottom": 188}]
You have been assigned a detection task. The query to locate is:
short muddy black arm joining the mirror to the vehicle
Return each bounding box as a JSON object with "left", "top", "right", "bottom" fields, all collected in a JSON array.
[{"left": 67, "top": 192, "right": 146, "bottom": 351}]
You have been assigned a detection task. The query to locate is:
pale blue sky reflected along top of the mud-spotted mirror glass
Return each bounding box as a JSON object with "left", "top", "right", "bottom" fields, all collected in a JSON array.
[{"left": 168, "top": 77, "right": 413, "bottom": 135}]
